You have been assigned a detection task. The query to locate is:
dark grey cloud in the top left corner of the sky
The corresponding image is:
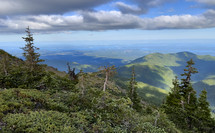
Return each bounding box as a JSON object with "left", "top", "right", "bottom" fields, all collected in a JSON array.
[{"left": 0, "top": 0, "right": 111, "bottom": 16}]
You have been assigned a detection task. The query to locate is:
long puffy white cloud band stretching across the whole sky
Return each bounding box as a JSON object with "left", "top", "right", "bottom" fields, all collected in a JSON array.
[{"left": 0, "top": 10, "right": 215, "bottom": 33}]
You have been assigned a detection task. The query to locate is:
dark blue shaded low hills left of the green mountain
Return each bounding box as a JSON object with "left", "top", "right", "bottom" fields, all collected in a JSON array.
[{"left": 41, "top": 51, "right": 126, "bottom": 72}]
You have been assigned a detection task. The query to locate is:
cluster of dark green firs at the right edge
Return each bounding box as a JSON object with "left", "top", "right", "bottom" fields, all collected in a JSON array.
[{"left": 163, "top": 60, "right": 213, "bottom": 132}]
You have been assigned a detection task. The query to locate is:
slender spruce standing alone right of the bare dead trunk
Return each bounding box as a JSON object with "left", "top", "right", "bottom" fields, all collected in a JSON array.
[{"left": 128, "top": 67, "right": 142, "bottom": 112}]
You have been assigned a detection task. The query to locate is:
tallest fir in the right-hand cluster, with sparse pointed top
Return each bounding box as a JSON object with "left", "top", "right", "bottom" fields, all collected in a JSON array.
[{"left": 164, "top": 59, "right": 198, "bottom": 130}]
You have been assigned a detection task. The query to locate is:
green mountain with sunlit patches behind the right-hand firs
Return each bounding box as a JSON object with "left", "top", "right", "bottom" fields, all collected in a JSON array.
[{"left": 118, "top": 52, "right": 215, "bottom": 105}]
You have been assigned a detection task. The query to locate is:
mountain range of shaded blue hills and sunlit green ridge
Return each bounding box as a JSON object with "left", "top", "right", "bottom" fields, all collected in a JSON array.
[{"left": 0, "top": 51, "right": 215, "bottom": 106}]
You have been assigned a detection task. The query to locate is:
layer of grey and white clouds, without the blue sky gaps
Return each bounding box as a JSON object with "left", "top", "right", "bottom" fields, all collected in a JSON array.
[{"left": 0, "top": 0, "right": 215, "bottom": 33}]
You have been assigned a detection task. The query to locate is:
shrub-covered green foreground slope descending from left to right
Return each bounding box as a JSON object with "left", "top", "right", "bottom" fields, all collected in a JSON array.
[{"left": 0, "top": 47, "right": 212, "bottom": 133}]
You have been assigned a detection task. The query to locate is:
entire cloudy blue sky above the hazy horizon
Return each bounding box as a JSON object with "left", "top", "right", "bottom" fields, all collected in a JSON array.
[{"left": 0, "top": 0, "right": 215, "bottom": 42}]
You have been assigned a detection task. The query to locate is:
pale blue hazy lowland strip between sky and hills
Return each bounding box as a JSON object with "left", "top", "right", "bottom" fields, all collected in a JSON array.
[{"left": 0, "top": 40, "right": 215, "bottom": 58}]
